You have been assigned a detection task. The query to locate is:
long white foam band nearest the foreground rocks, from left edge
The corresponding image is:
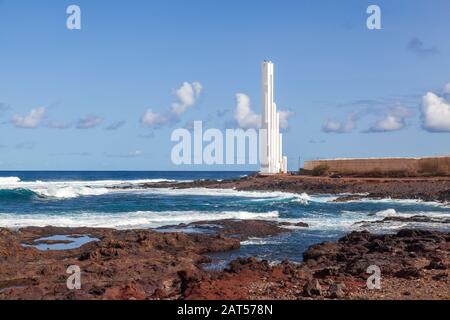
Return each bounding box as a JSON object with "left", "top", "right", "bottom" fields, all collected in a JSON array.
[{"left": 0, "top": 211, "right": 279, "bottom": 229}]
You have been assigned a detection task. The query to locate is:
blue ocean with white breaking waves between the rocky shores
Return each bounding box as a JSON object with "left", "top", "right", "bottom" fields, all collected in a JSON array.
[{"left": 0, "top": 171, "right": 450, "bottom": 262}]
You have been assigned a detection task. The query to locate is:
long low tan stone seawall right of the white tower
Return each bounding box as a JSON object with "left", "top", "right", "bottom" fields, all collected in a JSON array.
[{"left": 304, "top": 156, "right": 450, "bottom": 175}]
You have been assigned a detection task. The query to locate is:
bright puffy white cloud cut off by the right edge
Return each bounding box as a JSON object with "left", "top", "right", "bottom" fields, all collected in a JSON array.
[{"left": 422, "top": 92, "right": 450, "bottom": 132}]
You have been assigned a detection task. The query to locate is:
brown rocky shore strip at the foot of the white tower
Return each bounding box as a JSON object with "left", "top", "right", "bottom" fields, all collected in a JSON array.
[{"left": 135, "top": 175, "right": 450, "bottom": 202}]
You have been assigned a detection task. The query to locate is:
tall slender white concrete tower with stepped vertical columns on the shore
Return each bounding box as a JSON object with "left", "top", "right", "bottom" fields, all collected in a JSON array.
[{"left": 260, "top": 61, "right": 287, "bottom": 174}]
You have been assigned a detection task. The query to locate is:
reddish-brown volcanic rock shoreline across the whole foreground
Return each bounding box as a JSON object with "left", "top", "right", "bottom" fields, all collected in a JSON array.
[{"left": 0, "top": 220, "right": 450, "bottom": 300}]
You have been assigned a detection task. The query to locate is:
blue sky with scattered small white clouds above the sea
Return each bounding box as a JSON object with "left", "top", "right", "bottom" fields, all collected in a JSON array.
[{"left": 0, "top": 0, "right": 450, "bottom": 170}]
